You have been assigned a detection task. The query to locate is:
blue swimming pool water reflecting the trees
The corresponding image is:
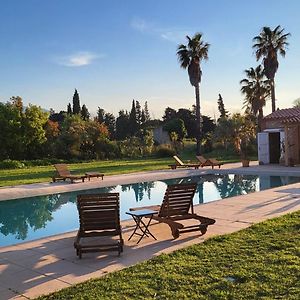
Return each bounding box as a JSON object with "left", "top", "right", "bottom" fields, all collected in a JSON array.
[{"left": 0, "top": 174, "right": 300, "bottom": 246}]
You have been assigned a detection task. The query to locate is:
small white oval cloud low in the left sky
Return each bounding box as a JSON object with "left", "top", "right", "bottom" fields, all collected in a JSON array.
[{"left": 55, "top": 51, "right": 103, "bottom": 67}]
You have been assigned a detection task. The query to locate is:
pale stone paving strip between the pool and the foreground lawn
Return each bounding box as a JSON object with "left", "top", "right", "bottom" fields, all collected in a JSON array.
[{"left": 0, "top": 166, "right": 300, "bottom": 300}]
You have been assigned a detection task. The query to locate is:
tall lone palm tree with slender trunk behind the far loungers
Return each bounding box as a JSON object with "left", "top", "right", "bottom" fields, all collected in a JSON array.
[{"left": 177, "top": 33, "right": 209, "bottom": 155}]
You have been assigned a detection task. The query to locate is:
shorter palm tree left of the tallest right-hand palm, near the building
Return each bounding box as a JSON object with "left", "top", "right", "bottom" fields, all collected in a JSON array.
[{"left": 240, "top": 65, "right": 270, "bottom": 131}]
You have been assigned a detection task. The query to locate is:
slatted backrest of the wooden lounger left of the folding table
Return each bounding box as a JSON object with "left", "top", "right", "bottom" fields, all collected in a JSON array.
[{"left": 77, "top": 193, "right": 120, "bottom": 232}]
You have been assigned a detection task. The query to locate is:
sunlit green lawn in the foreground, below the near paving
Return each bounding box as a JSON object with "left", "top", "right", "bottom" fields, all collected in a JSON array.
[{"left": 39, "top": 211, "right": 300, "bottom": 300}]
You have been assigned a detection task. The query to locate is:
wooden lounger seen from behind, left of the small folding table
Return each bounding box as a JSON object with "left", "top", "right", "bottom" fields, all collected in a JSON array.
[{"left": 74, "top": 193, "right": 124, "bottom": 258}]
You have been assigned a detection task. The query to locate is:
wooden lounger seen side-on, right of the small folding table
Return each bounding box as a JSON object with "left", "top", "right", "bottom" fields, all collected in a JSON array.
[{"left": 130, "top": 183, "right": 215, "bottom": 239}]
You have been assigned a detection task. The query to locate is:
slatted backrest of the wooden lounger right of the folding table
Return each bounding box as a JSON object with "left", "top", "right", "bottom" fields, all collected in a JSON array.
[{"left": 159, "top": 183, "right": 197, "bottom": 217}]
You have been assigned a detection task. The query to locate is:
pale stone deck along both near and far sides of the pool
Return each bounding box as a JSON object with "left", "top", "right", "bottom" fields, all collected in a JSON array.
[{"left": 0, "top": 163, "right": 300, "bottom": 299}]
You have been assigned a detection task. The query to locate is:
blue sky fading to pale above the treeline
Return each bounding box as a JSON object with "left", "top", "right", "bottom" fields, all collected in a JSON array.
[{"left": 0, "top": 0, "right": 300, "bottom": 118}]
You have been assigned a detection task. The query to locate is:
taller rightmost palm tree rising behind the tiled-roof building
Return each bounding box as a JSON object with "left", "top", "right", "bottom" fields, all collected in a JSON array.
[{"left": 252, "top": 25, "right": 290, "bottom": 112}]
